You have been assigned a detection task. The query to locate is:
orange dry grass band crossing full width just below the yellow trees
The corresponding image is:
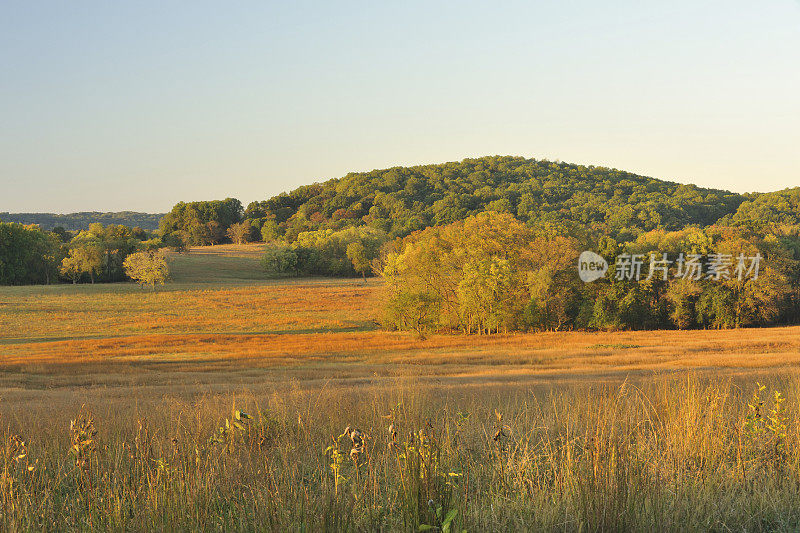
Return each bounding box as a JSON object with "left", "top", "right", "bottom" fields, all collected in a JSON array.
[{"left": 0, "top": 322, "right": 800, "bottom": 374}]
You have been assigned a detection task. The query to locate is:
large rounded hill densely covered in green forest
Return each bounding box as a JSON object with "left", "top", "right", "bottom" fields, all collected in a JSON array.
[{"left": 245, "top": 156, "right": 756, "bottom": 240}]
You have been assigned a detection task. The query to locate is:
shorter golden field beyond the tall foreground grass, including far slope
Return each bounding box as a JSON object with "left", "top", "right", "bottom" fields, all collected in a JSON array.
[{"left": 0, "top": 245, "right": 800, "bottom": 388}]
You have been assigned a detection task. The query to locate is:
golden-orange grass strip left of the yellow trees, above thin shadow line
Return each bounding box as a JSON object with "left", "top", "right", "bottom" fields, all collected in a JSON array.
[{"left": 0, "top": 280, "right": 374, "bottom": 338}]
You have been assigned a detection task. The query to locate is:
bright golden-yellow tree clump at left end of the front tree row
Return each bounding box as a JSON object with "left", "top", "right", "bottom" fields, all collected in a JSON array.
[{"left": 382, "top": 212, "right": 577, "bottom": 335}]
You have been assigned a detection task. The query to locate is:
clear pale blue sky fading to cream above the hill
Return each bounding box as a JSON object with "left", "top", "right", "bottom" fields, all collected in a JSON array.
[{"left": 0, "top": 0, "right": 800, "bottom": 213}]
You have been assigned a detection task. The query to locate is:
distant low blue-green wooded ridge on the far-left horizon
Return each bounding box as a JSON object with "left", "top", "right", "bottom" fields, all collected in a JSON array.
[{"left": 0, "top": 211, "right": 164, "bottom": 231}]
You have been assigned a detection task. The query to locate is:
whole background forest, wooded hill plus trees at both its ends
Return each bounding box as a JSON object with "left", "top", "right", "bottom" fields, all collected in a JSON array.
[{"left": 160, "top": 156, "right": 800, "bottom": 254}]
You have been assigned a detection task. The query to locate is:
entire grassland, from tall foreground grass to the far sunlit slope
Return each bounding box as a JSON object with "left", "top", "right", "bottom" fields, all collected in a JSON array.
[{"left": 0, "top": 245, "right": 800, "bottom": 531}]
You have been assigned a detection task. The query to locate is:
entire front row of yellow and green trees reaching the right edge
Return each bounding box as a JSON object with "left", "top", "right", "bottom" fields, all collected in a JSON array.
[{"left": 381, "top": 212, "right": 800, "bottom": 335}]
